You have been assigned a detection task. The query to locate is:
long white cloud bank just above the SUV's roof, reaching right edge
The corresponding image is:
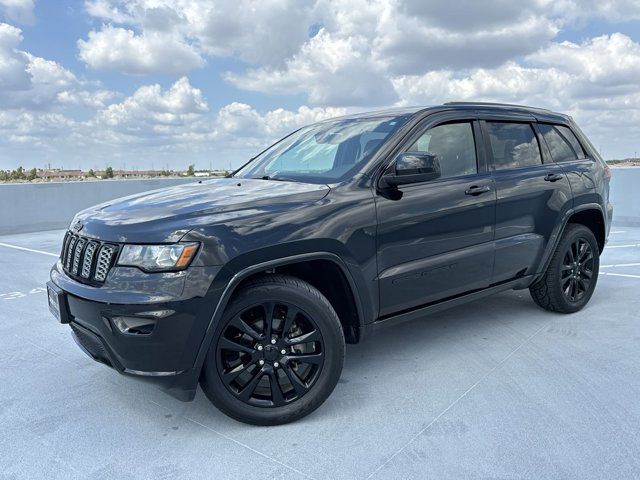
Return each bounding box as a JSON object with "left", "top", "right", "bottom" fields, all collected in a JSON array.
[{"left": 393, "top": 33, "right": 640, "bottom": 109}]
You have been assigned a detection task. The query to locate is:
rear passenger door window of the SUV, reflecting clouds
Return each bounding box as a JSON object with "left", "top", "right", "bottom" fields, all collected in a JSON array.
[{"left": 487, "top": 122, "right": 542, "bottom": 170}]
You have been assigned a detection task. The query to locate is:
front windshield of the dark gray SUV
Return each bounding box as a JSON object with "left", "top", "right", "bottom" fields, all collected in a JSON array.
[{"left": 234, "top": 115, "right": 409, "bottom": 183}]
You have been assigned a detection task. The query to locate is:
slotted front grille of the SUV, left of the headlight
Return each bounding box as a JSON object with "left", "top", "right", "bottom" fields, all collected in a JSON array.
[{"left": 60, "top": 232, "right": 118, "bottom": 283}]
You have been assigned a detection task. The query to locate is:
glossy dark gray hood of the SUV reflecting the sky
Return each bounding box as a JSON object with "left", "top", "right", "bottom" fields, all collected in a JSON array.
[{"left": 71, "top": 178, "right": 330, "bottom": 243}]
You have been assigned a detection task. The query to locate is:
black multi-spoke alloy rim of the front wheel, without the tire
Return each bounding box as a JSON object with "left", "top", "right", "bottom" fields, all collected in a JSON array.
[{"left": 216, "top": 302, "right": 324, "bottom": 407}]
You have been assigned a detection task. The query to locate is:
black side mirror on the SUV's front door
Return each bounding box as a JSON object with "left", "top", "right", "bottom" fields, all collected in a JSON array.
[{"left": 381, "top": 152, "right": 442, "bottom": 187}]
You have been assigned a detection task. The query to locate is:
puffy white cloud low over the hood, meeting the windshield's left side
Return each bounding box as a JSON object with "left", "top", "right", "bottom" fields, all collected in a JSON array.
[{"left": 87, "top": 77, "right": 345, "bottom": 149}]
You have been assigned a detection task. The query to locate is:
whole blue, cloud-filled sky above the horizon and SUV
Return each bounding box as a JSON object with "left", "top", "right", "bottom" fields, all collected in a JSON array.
[{"left": 0, "top": 0, "right": 640, "bottom": 170}]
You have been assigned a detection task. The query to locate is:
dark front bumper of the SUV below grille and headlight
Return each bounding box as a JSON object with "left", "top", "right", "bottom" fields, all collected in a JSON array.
[{"left": 47, "top": 265, "right": 222, "bottom": 400}]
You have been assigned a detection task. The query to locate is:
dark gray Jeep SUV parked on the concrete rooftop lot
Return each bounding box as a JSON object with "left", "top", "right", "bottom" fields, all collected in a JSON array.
[{"left": 48, "top": 103, "right": 612, "bottom": 425}]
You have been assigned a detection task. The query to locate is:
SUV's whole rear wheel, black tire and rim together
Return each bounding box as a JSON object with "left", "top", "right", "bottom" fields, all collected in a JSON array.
[{"left": 529, "top": 223, "right": 600, "bottom": 313}]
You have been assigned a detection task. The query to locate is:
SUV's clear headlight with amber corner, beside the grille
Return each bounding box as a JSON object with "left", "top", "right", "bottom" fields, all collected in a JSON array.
[{"left": 118, "top": 243, "right": 198, "bottom": 272}]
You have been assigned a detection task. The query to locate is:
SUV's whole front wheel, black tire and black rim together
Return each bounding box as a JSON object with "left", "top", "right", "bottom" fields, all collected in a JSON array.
[{"left": 201, "top": 274, "right": 345, "bottom": 425}]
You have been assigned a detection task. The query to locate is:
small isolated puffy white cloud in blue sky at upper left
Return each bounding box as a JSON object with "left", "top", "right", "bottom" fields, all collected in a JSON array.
[{"left": 78, "top": 25, "right": 204, "bottom": 75}]
